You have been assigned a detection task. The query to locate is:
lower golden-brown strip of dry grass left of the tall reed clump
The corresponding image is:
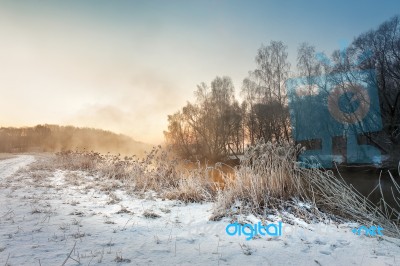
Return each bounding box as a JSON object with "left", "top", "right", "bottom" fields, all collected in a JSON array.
[{"left": 45, "top": 147, "right": 216, "bottom": 204}]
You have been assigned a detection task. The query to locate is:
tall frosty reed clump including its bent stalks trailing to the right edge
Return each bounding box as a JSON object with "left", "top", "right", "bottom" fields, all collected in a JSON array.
[{"left": 213, "top": 142, "right": 400, "bottom": 237}]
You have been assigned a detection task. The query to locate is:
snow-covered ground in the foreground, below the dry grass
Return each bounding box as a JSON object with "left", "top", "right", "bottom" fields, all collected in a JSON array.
[{"left": 0, "top": 155, "right": 400, "bottom": 266}]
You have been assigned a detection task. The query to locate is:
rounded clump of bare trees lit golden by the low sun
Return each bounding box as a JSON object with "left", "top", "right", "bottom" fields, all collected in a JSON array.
[{"left": 164, "top": 77, "right": 243, "bottom": 161}]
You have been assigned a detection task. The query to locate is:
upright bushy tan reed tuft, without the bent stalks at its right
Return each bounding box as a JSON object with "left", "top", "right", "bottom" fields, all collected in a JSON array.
[{"left": 214, "top": 143, "right": 303, "bottom": 210}]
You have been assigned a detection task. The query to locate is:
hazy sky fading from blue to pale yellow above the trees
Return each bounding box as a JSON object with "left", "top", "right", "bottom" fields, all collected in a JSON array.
[{"left": 0, "top": 0, "right": 400, "bottom": 143}]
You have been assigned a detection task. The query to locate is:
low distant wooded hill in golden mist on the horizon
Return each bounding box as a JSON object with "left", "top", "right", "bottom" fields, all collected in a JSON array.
[{"left": 0, "top": 125, "right": 151, "bottom": 156}]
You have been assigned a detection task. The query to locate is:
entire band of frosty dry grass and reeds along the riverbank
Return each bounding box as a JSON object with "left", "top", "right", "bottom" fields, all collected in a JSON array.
[{"left": 41, "top": 142, "right": 400, "bottom": 237}]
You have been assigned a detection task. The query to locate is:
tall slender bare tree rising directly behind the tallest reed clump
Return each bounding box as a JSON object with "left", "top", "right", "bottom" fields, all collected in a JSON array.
[{"left": 242, "top": 41, "right": 290, "bottom": 144}]
